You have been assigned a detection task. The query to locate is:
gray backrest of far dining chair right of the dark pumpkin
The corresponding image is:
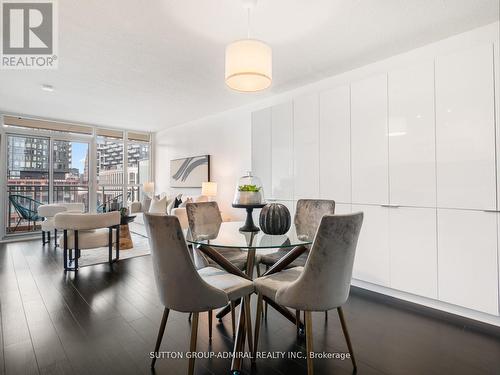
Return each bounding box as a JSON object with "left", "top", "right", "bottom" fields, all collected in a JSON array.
[{"left": 293, "top": 199, "right": 335, "bottom": 240}]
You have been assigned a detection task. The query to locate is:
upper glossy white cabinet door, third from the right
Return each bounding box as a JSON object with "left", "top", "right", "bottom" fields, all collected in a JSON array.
[{"left": 351, "top": 74, "right": 389, "bottom": 204}]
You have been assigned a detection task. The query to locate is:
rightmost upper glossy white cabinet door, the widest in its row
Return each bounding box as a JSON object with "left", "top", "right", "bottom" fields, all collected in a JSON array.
[{"left": 436, "top": 45, "right": 496, "bottom": 209}]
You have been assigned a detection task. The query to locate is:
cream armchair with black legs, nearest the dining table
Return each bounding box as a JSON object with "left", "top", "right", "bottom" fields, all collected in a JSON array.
[{"left": 54, "top": 211, "right": 121, "bottom": 271}]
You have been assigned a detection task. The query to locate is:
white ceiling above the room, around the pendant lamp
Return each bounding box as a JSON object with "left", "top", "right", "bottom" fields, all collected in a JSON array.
[{"left": 0, "top": 0, "right": 499, "bottom": 131}]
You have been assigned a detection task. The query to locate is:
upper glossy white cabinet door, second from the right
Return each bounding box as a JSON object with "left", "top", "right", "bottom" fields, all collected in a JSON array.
[{"left": 388, "top": 61, "right": 436, "bottom": 207}]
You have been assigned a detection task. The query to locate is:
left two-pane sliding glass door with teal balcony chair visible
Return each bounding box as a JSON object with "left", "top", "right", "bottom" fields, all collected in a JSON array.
[{"left": 6, "top": 134, "right": 89, "bottom": 234}]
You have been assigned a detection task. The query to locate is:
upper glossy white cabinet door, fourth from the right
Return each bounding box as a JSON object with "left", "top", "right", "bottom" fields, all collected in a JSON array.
[{"left": 319, "top": 86, "right": 351, "bottom": 203}]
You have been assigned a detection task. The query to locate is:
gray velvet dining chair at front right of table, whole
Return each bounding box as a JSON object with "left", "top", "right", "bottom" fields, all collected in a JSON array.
[{"left": 253, "top": 212, "right": 363, "bottom": 375}]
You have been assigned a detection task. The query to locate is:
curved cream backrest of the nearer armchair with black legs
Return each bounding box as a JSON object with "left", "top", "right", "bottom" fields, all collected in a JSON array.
[{"left": 54, "top": 211, "right": 121, "bottom": 230}]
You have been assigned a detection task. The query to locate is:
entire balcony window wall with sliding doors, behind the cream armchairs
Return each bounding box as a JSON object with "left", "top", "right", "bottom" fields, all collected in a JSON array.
[{"left": 0, "top": 125, "right": 152, "bottom": 238}]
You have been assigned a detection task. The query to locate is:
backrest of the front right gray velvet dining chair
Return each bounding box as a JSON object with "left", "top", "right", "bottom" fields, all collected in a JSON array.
[{"left": 276, "top": 212, "right": 363, "bottom": 311}]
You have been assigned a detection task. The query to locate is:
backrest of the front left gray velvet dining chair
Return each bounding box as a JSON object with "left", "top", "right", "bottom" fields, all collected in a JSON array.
[{"left": 144, "top": 213, "right": 228, "bottom": 312}]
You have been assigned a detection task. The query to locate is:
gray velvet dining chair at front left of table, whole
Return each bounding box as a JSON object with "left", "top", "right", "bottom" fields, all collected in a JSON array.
[{"left": 144, "top": 214, "right": 254, "bottom": 374}]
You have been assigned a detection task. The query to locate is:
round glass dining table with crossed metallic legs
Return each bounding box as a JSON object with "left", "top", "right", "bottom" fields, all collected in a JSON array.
[{"left": 186, "top": 222, "right": 312, "bottom": 374}]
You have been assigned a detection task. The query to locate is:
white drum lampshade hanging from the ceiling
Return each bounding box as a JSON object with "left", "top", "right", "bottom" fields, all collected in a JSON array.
[{"left": 225, "top": 39, "right": 273, "bottom": 92}]
